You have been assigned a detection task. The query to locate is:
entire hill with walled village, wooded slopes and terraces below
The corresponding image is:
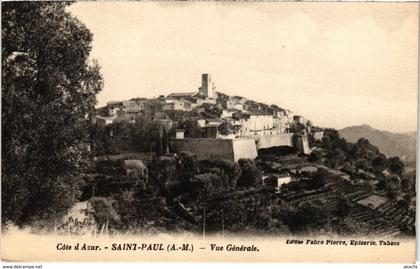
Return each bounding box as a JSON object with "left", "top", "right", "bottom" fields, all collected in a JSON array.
[{"left": 58, "top": 74, "right": 416, "bottom": 236}]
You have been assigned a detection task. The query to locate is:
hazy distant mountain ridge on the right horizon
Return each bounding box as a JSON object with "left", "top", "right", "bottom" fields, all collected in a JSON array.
[{"left": 339, "top": 124, "right": 417, "bottom": 163}]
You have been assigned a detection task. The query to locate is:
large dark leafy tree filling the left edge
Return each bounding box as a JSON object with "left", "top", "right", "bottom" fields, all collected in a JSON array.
[{"left": 2, "top": 2, "right": 102, "bottom": 225}]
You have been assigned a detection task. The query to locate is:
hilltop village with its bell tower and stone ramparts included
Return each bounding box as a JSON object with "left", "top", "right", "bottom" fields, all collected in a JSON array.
[{"left": 96, "top": 74, "right": 323, "bottom": 161}]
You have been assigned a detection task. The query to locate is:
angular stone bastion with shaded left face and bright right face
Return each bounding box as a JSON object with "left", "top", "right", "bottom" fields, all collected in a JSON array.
[{"left": 171, "top": 138, "right": 257, "bottom": 162}]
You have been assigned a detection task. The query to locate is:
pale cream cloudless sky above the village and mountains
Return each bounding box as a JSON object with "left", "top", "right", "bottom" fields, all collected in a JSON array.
[{"left": 69, "top": 2, "right": 418, "bottom": 132}]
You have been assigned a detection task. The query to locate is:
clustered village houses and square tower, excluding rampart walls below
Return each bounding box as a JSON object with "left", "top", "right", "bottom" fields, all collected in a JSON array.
[{"left": 96, "top": 74, "right": 318, "bottom": 158}]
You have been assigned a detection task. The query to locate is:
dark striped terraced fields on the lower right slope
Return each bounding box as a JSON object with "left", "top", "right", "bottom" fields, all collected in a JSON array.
[{"left": 202, "top": 171, "right": 415, "bottom": 236}]
